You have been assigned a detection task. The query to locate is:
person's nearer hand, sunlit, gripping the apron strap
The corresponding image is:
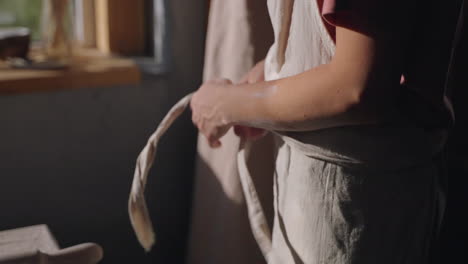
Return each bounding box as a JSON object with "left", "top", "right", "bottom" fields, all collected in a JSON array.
[{"left": 190, "top": 79, "right": 236, "bottom": 148}]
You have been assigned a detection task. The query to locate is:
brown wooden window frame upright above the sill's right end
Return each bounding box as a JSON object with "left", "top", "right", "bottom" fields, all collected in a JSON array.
[{"left": 80, "top": 0, "right": 171, "bottom": 74}]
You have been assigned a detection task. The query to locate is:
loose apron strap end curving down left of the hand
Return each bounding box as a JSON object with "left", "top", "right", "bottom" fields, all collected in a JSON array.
[{"left": 128, "top": 94, "right": 192, "bottom": 251}]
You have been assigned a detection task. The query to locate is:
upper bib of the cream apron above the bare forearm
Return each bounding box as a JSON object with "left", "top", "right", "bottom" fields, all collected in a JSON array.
[{"left": 265, "top": 0, "right": 335, "bottom": 80}]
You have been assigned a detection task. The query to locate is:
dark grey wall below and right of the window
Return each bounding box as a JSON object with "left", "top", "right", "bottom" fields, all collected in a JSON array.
[{"left": 0, "top": 0, "right": 205, "bottom": 263}]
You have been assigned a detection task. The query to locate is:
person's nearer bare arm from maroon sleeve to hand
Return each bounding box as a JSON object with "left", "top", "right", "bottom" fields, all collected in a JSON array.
[{"left": 191, "top": 27, "right": 401, "bottom": 141}]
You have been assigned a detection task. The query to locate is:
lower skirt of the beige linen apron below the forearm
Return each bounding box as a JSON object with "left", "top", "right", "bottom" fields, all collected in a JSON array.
[{"left": 268, "top": 126, "right": 438, "bottom": 264}]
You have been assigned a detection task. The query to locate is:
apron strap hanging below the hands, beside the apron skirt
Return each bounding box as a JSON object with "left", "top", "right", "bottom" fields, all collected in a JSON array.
[{"left": 237, "top": 140, "right": 272, "bottom": 261}]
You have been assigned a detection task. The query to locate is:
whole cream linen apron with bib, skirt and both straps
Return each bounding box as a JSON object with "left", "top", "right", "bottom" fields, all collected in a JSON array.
[{"left": 129, "top": 0, "right": 439, "bottom": 264}]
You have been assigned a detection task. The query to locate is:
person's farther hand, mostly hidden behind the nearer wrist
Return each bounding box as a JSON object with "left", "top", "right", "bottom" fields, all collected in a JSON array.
[{"left": 234, "top": 60, "right": 267, "bottom": 140}]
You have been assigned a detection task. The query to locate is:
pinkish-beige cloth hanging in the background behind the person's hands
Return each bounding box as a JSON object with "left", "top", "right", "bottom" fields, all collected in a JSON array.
[{"left": 187, "top": 0, "right": 274, "bottom": 264}]
